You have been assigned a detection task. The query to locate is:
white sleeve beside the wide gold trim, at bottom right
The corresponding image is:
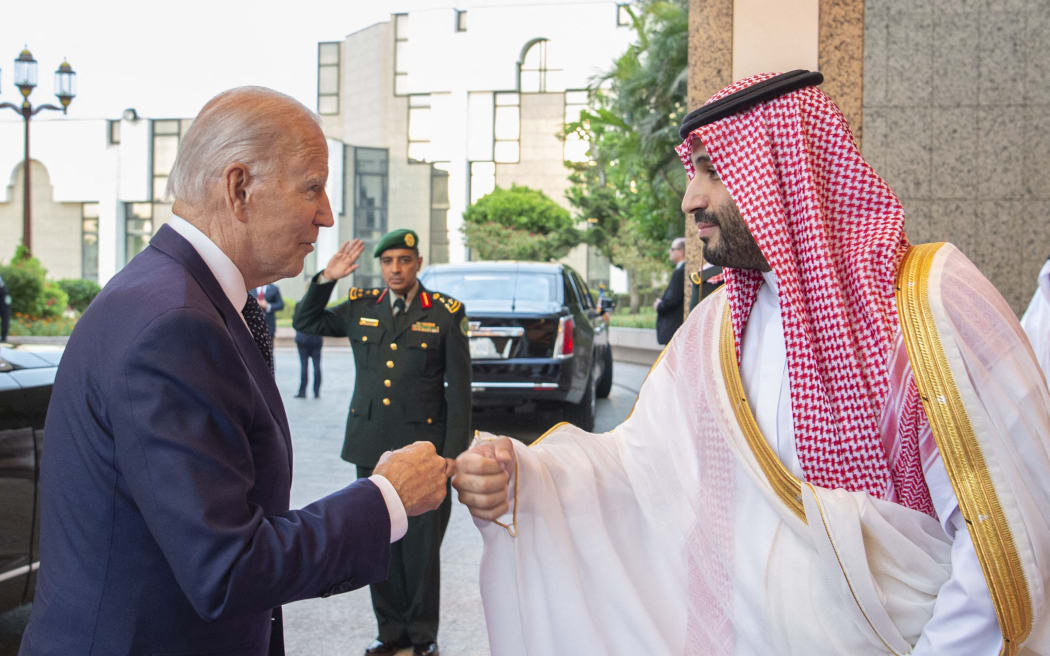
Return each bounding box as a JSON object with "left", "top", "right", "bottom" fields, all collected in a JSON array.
[{"left": 911, "top": 457, "right": 1003, "bottom": 656}]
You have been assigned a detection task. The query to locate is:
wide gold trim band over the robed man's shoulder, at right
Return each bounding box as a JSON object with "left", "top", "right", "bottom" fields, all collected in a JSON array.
[{"left": 897, "top": 242, "right": 1032, "bottom": 656}]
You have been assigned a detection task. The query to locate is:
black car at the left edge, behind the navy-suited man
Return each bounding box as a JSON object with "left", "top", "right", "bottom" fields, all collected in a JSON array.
[{"left": 0, "top": 343, "right": 62, "bottom": 612}]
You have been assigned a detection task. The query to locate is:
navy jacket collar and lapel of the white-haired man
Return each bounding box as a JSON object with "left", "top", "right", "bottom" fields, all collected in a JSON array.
[{"left": 149, "top": 225, "right": 289, "bottom": 449}]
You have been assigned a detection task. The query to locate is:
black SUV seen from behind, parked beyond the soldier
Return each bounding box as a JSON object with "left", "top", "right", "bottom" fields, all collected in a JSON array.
[{"left": 420, "top": 261, "right": 612, "bottom": 430}]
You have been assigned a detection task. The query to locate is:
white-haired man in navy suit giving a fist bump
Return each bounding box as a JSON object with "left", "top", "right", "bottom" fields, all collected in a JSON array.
[{"left": 19, "top": 87, "right": 450, "bottom": 656}]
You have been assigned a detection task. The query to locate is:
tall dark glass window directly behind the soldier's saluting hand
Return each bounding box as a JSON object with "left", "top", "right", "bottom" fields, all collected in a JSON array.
[{"left": 354, "top": 148, "right": 389, "bottom": 287}]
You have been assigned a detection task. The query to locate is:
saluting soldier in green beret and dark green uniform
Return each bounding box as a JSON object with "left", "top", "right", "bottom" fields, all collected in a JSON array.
[{"left": 293, "top": 230, "right": 470, "bottom": 656}]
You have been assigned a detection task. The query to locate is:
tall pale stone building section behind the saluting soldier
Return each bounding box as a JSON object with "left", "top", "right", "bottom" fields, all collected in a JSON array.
[{"left": 317, "top": 1, "right": 634, "bottom": 285}]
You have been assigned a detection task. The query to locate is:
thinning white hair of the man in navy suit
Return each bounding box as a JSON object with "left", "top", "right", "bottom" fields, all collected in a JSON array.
[{"left": 167, "top": 86, "right": 319, "bottom": 205}]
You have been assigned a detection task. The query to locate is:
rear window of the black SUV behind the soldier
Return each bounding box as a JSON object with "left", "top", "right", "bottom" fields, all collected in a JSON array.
[{"left": 426, "top": 271, "right": 562, "bottom": 306}]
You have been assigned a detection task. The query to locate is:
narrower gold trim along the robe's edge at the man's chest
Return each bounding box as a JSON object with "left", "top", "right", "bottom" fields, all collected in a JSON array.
[{"left": 718, "top": 303, "right": 806, "bottom": 524}]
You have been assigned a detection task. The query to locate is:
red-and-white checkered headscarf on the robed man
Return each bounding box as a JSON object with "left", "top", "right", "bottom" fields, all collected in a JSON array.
[{"left": 677, "top": 73, "right": 932, "bottom": 513}]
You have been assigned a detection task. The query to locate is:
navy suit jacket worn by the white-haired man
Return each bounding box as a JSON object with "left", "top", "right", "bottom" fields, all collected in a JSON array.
[{"left": 19, "top": 226, "right": 390, "bottom": 656}]
